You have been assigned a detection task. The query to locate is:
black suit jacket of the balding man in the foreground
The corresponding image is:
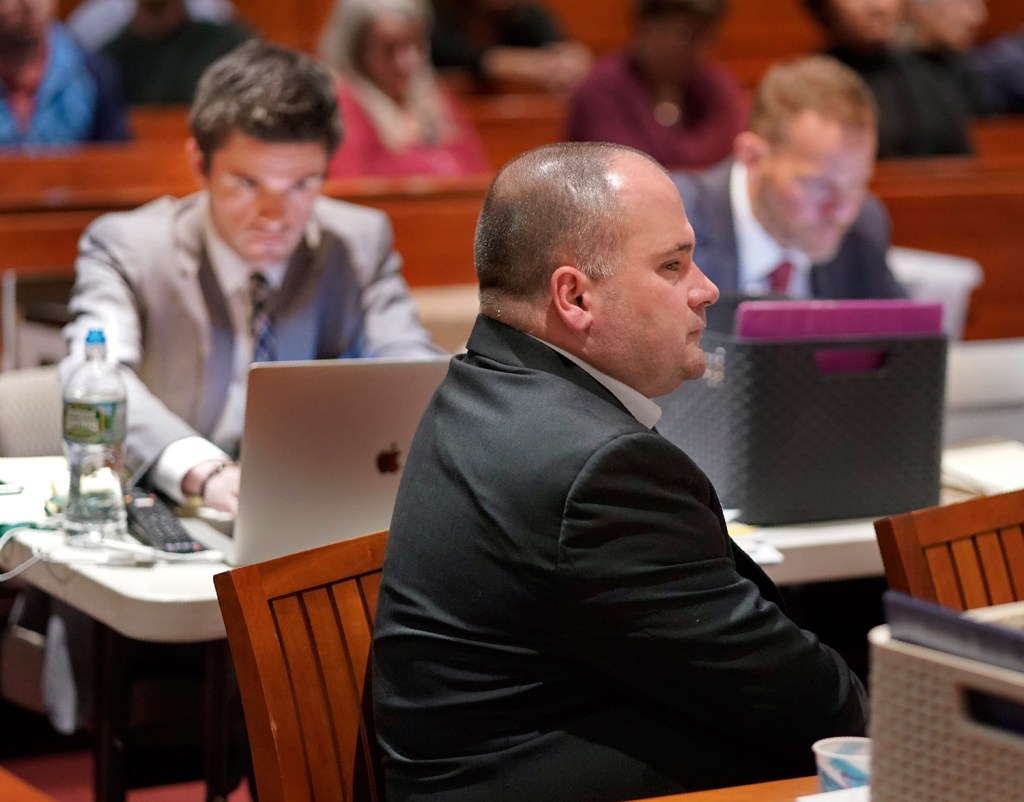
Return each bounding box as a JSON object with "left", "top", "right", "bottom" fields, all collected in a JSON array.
[{"left": 374, "top": 318, "right": 864, "bottom": 802}]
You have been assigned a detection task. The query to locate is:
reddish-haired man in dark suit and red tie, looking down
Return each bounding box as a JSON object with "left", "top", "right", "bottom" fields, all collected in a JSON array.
[{"left": 674, "top": 56, "right": 906, "bottom": 305}]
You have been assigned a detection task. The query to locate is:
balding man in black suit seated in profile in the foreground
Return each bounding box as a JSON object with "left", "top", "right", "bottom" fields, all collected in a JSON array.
[{"left": 373, "top": 142, "right": 865, "bottom": 802}]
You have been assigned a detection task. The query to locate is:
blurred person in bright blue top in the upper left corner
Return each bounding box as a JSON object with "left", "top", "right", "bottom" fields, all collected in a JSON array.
[{"left": 0, "top": 0, "right": 131, "bottom": 146}]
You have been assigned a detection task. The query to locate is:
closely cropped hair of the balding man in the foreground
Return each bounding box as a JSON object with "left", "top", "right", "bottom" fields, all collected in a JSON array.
[{"left": 473, "top": 142, "right": 664, "bottom": 311}]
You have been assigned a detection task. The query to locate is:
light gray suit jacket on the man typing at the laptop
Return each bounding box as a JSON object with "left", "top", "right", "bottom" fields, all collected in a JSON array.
[{"left": 61, "top": 193, "right": 437, "bottom": 470}]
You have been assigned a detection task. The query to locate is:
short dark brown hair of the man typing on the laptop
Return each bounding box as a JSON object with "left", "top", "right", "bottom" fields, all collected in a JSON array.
[{"left": 188, "top": 39, "right": 342, "bottom": 167}]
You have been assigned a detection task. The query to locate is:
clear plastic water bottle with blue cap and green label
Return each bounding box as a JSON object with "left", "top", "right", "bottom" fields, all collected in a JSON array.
[{"left": 63, "top": 329, "right": 127, "bottom": 545}]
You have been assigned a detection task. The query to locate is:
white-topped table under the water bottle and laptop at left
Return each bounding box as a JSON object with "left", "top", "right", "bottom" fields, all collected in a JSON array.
[{"left": 0, "top": 457, "right": 230, "bottom": 802}]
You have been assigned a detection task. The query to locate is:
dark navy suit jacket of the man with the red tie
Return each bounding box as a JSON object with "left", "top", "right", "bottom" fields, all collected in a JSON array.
[{"left": 673, "top": 159, "right": 906, "bottom": 299}]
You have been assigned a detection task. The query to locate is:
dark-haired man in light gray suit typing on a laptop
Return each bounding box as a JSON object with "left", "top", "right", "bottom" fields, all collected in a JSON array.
[{"left": 62, "top": 41, "right": 438, "bottom": 513}]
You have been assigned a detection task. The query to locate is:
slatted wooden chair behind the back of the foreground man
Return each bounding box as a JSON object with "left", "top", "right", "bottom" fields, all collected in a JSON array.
[{"left": 214, "top": 532, "right": 388, "bottom": 802}]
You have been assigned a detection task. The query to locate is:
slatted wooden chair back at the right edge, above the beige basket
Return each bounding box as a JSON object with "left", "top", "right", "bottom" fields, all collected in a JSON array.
[{"left": 874, "top": 491, "right": 1024, "bottom": 610}]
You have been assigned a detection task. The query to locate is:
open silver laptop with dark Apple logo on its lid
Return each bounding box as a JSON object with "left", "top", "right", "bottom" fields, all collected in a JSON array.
[{"left": 183, "top": 356, "right": 451, "bottom": 565}]
